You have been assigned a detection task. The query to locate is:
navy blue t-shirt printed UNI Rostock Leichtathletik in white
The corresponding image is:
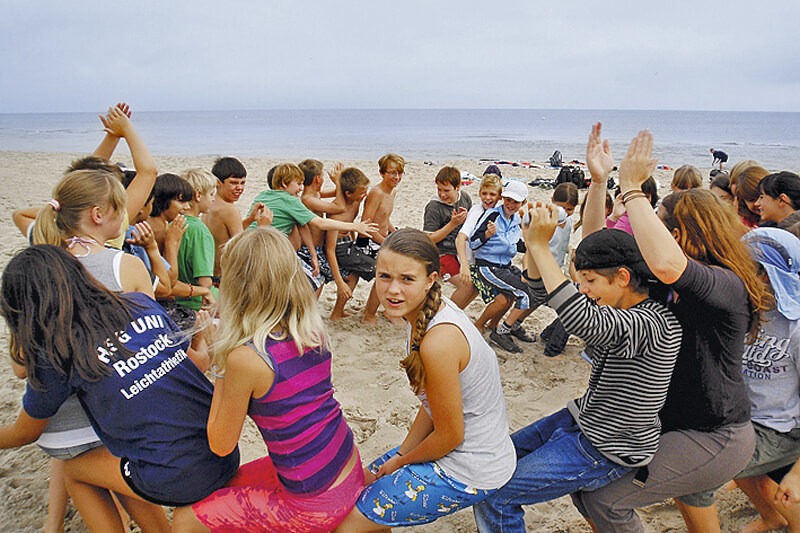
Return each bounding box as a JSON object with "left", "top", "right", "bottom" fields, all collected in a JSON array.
[{"left": 22, "top": 293, "right": 239, "bottom": 504}]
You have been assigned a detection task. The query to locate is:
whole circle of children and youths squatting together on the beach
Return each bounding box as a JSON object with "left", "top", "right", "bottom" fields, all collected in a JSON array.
[{"left": 0, "top": 104, "right": 800, "bottom": 532}]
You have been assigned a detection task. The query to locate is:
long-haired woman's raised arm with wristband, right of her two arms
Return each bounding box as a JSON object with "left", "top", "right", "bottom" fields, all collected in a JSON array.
[{"left": 620, "top": 130, "right": 688, "bottom": 285}]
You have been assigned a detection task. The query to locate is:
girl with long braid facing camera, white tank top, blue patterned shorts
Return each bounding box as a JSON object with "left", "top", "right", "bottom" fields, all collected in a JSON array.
[{"left": 337, "top": 228, "right": 516, "bottom": 532}]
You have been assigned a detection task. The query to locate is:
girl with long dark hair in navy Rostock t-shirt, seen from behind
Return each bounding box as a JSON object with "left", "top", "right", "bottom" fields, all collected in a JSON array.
[{"left": 0, "top": 245, "right": 239, "bottom": 532}]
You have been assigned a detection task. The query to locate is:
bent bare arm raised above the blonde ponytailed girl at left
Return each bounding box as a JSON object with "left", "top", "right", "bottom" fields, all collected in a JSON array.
[{"left": 100, "top": 107, "right": 158, "bottom": 220}]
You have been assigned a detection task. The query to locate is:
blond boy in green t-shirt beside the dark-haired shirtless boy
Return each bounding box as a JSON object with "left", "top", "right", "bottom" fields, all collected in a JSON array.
[{"left": 177, "top": 168, "right": 217, "bottom": 311}]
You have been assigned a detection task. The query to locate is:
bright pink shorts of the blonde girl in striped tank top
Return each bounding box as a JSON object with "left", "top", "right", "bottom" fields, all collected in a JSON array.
[{"left": 192, "top": 456, "right": 364, "bottom": 532}]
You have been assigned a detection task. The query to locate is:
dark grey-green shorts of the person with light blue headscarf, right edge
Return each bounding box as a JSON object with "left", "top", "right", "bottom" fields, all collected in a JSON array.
[{"left": 677, "top": 423, "right": 800, "bottom": 507}]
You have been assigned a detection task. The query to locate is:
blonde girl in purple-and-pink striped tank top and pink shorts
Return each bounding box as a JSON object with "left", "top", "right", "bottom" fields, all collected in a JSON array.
[{"left": 179, "top": 228, "right": 364, "bottom": 532}]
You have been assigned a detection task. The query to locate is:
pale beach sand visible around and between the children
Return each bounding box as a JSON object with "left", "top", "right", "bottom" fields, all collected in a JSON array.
[{"left": 0, "top": 148, "right": 756, "bottom": 533}]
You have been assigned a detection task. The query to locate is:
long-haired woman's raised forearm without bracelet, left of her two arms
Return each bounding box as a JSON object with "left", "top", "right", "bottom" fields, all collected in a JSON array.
[{"left": 581, "top": 122, "right": 614, "bottom": 237}]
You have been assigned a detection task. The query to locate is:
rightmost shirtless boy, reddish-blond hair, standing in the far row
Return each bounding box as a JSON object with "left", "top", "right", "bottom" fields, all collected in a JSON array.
[{"left": 361, "top": 154, "right": 406, "bottom": 324}]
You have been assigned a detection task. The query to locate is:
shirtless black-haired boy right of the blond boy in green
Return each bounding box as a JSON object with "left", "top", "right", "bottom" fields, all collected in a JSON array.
[{"left": 203, "top": 157, "right": 271, "bottom": 280}]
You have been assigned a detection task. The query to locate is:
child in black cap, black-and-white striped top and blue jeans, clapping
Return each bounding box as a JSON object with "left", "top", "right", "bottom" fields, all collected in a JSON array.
[{"left": 475, "top": 205, "right": 681, "bottom": 532}]
